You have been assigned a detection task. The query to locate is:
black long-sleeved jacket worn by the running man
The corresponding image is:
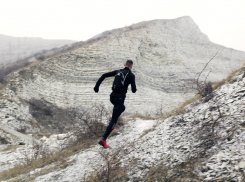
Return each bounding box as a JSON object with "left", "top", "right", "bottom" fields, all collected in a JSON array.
[{"left": 94, "top": 67, "right": 137, "bottom": 98}]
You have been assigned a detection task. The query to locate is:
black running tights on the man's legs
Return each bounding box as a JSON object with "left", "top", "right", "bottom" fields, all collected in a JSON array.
[{"left": 103, "top": 96, "right": 125, "bottom": 139}]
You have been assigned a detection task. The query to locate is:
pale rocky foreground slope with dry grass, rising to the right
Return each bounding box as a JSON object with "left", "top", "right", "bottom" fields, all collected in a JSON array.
[{"left": 1, "top": 69, "right": 245, "bottom": 182}]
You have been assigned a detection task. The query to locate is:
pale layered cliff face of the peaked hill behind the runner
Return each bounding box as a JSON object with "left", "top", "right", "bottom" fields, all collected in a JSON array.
[{"left": 3, "top": 17, "right": 245, "bottom": 114}]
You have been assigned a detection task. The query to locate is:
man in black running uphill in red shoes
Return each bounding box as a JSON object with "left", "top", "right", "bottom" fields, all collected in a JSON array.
[{"left": 94, "top": 60, "right": 137, "bottom": 148}]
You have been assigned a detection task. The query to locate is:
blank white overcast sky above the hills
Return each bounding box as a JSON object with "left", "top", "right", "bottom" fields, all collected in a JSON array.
[{"left": 0, "top": 0, "right": 245, "bottom": 51}]
